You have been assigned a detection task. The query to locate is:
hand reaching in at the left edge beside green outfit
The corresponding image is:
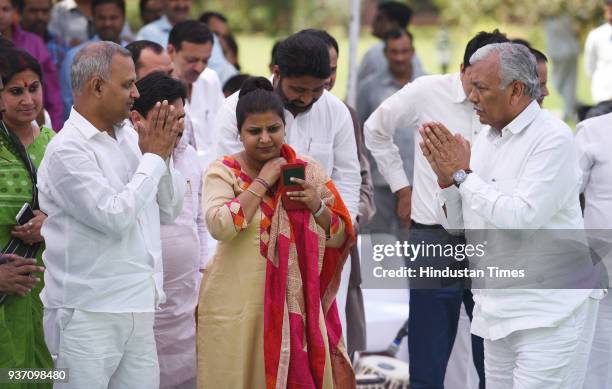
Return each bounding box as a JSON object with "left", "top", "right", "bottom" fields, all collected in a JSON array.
[{"left": 0, "top": 254, "right": 45, "bottom": 297}]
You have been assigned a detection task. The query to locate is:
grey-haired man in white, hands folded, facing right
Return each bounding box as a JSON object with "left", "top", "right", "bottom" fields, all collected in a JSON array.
[{"left": 38, "top": 42, "right": 185, "bottom": 389}]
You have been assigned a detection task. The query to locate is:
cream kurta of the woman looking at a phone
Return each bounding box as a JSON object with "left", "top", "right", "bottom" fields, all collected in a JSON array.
[{"left": 197, "top": 152, "right": 354, "bottom": 388}]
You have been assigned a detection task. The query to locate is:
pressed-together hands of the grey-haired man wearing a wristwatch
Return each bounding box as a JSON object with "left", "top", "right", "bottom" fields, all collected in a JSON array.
[{"left": 419, "top": 123, "right": 470, "bottom": 184}]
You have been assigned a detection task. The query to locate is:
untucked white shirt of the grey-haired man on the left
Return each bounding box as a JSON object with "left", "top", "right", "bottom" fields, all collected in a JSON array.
[{"left": 38, "top": 109, "right": 185, "bottom": 312}]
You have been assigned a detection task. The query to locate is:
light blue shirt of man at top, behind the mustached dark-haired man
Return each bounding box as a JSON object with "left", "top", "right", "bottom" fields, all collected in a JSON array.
[{"left": 136, "top": 15, "right": 238, "bottom": 85}]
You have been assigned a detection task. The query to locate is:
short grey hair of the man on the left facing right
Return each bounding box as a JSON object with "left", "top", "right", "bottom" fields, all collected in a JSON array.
[{"left": 70, "top": 41, "right": 132, "bottom": 96}]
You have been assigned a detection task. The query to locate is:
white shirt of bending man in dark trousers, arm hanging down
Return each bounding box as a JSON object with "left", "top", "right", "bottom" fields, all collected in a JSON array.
[{"left": 364, "top": 73, "right": 482, "bottom": 225}]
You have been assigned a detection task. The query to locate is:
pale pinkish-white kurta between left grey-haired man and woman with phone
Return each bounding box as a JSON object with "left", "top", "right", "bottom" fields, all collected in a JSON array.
[{"left": 154, "top": 134, "right": 208, "bottom": 389}]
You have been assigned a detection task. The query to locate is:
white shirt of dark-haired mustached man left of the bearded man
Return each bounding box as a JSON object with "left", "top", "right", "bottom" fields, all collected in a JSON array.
[{"left": 185, "top": 68, "right": 224, "bottom": 169}]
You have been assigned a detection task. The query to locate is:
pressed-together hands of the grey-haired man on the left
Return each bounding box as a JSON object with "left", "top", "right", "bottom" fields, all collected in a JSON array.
[{"left": 134, "top": 100, "right": 183, "bottom": 160}]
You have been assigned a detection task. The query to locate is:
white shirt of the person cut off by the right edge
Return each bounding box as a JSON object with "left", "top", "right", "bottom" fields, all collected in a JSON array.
[{"left": 576, "top": 113, "right": 612, "bottom": 229}]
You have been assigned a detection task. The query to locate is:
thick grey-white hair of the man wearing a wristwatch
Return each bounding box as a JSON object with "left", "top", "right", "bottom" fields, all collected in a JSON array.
[{"left": 470, "top": 42, "right": 541, "bottom": 100}]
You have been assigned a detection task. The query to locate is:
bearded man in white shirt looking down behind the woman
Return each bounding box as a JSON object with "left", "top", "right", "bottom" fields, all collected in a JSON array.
[{"left": 214, "top": 31, "right": 361, "bottom": 220}]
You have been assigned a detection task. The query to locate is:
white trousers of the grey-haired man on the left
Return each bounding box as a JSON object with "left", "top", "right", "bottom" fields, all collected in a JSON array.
[{"left": 44, "top": 308, "right": 159, "bottom": 389}]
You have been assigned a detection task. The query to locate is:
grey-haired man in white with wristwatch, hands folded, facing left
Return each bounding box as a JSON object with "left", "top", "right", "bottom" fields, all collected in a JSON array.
[{"left": 421, "top": 43, "right": 603, "bottom": 389}]
